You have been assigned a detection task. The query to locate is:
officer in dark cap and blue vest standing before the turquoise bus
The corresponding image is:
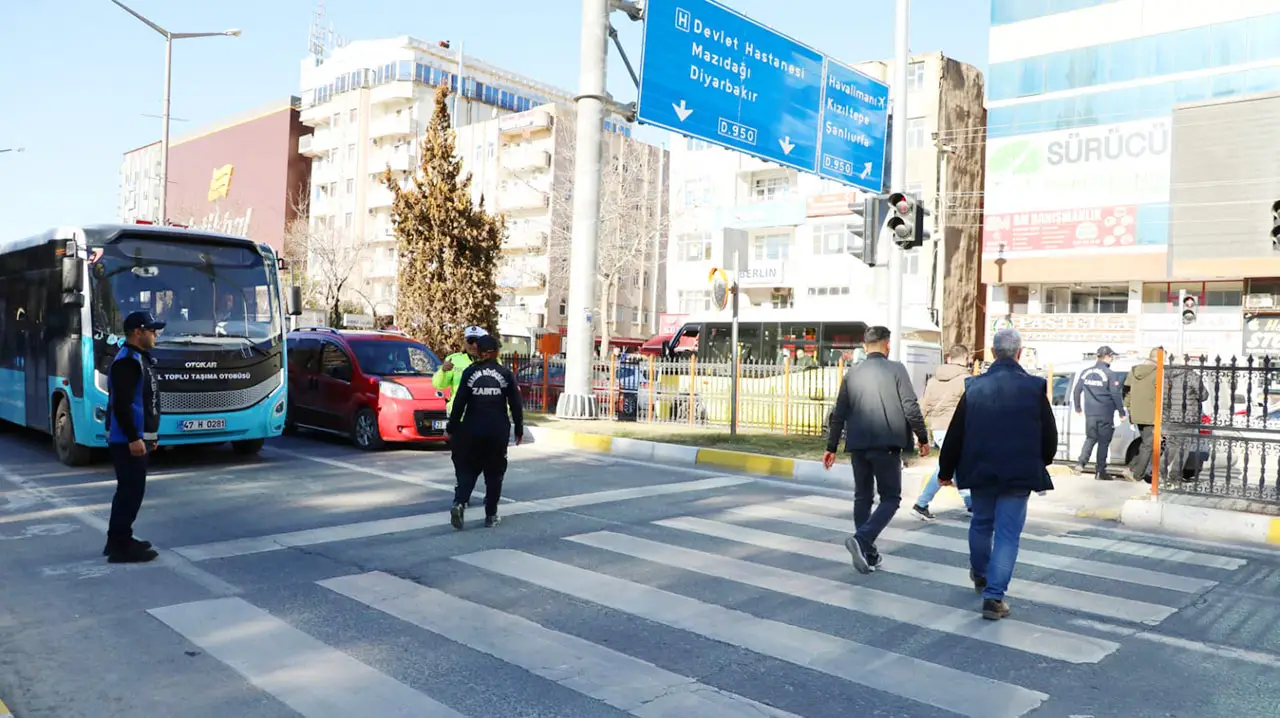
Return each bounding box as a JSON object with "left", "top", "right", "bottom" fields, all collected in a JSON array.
[{"left": 102, "top": 311, "right": 165, "bottom": 563}]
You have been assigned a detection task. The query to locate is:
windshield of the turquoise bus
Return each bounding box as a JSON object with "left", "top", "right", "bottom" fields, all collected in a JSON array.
[{"left": 90, "top": 237, "right": 282, "bottom": 344}]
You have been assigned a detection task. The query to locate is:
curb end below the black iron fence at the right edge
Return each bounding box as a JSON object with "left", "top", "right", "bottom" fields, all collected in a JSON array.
[{"left": 1120, "top": 498, "right": 1280, "bottom": 545}]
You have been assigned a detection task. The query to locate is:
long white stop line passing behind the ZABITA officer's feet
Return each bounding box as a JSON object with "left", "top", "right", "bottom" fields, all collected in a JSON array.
[{"left": 173, "top": 476, "right": 751, "bottom": 562}]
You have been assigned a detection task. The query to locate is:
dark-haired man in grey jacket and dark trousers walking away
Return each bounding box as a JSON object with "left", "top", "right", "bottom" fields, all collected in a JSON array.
[{"left": 822, "top": 326, "right": 929, "bottom": 573}]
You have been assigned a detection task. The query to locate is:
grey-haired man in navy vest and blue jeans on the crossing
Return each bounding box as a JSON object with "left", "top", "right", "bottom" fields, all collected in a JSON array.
[{"left": 938, "top": 329, "right": 1057, "bottom": 621}]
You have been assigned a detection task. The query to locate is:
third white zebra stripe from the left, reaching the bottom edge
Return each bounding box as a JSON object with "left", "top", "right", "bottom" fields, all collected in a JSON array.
[{"left": 454, "top": 549, "right": 1048, "bottom": 718}]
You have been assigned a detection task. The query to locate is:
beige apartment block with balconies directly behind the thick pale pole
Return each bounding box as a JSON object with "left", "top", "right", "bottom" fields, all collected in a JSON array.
[{"left": 455, "top": 104, "right": 667, "bottom": 349}]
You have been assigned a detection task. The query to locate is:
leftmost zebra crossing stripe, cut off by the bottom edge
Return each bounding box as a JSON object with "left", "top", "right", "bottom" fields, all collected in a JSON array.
[{"left": 147, "top": 598, "right": 463, "bottom": 718}]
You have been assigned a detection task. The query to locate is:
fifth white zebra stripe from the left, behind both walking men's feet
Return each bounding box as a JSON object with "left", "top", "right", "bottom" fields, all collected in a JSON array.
[{"left": 654, "top": 517, "right": 1178, "bottom": 626}]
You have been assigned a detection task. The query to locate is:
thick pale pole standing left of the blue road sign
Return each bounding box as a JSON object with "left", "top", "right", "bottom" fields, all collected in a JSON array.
[{"left": 556, "top": 0, "right": 609, "bottom": 419}]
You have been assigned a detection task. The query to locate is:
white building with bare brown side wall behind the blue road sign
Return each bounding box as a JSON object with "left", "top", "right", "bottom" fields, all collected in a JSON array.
[{"left": 667, "top": 54, "right": 984, "bottom": 346}]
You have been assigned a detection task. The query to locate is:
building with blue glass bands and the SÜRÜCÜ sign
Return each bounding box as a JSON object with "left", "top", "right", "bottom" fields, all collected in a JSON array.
[{"left": 982, "top": 0, "right": 1280, "bottom": 363}]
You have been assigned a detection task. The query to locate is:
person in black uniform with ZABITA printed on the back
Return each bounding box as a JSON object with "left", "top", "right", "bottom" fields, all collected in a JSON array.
[{"left": 448, "top": 335, "right": 525, "bottom": 531}]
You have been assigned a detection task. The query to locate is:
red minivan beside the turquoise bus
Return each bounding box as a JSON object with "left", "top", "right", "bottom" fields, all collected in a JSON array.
[{"left": 284, "top": 328, "right": 448, "bottom": 451}]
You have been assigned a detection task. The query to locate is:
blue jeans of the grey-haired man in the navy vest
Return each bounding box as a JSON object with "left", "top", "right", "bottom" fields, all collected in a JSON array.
[{"left": 969, "top": 491, "right": 1030, "bottom": 600}]
